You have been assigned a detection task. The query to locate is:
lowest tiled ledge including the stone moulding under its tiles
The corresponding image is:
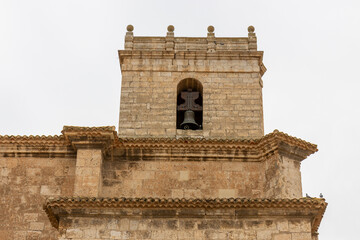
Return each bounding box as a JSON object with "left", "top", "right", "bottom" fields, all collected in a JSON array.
[{"left": 43, "top": 197, "right": 327, "bottom": 234}]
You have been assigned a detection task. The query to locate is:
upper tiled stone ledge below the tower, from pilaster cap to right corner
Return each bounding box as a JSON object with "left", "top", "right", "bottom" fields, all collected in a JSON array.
[{"left": 114, "top": 130, "right": 317, "bottom": 162}]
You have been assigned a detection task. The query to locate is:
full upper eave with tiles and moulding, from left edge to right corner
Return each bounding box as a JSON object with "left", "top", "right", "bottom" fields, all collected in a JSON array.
[{"left": 0, "top": 126, "right": 317, "bottom": 161}]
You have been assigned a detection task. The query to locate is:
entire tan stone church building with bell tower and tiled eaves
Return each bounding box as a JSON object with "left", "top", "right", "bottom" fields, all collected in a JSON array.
[{"left": 0, "top": 25, "right": 327, "bottom": 240}]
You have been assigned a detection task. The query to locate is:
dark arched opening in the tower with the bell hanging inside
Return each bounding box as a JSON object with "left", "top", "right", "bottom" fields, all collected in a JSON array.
[{"left": 176, "top": 78, "right": 203, "bottom": 130}]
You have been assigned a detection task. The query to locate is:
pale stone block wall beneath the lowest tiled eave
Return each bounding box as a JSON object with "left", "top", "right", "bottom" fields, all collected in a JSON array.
[{"left": 60, "top": 209, "right": 311, "bottom": 240}]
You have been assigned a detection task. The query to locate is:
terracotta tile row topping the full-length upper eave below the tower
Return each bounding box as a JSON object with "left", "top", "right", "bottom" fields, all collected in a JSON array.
[{"left": 0, "top": 129, "right": 317, "bottom": 158}]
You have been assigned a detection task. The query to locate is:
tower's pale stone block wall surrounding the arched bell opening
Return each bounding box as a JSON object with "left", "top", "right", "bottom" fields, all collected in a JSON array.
[{"left": 119, "top": 59, "right": 264, "bottom": 138}]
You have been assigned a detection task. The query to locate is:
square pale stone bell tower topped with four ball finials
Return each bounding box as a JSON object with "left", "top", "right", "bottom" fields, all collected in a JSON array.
[{"left": 119, "top": 26, "right": 266, "bottom": 139}]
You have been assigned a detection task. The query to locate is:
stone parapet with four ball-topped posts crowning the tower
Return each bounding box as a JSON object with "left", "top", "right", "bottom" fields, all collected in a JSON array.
[{"left": 125, "top": 25, "right": 257, "bottom": 52}]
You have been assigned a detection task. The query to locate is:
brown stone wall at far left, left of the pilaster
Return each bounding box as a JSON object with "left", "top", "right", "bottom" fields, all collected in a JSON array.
[{"left": 0, "top": 157, "right": 75, "bottom": 240}]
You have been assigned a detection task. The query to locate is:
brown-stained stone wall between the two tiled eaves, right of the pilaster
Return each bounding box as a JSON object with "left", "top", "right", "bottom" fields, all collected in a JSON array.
[{"left": 102, "top": 160, "right": 264, "bottom": 198}]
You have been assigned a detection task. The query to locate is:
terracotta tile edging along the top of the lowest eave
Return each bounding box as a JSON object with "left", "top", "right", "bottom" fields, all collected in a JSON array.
[{"left": 43, "top": 197, "right": 327, "bottom": 233}]
